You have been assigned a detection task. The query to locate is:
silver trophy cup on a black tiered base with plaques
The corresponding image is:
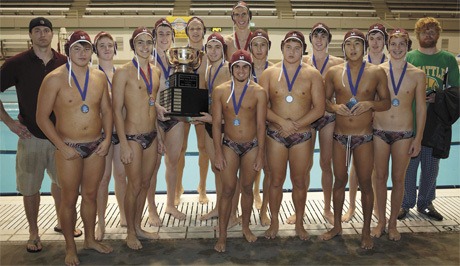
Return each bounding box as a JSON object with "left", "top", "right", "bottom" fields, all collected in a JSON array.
[{"left": 160, "top": 47, "right": 208, "bottom": 117}]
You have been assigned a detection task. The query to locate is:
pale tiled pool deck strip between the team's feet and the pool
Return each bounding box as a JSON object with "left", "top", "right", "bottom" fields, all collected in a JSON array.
[{"left": 0, "top": 189, "right": 460, "bottom": 242}]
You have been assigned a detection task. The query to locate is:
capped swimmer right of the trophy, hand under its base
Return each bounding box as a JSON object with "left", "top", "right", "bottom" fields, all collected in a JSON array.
[{"left": 194, "top": 32, "right": 235, "bottom": 221}]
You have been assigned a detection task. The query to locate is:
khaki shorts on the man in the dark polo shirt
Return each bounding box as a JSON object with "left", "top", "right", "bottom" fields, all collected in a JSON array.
[{"left": 16, "top": 136, "right": 58, "bottom": 196}]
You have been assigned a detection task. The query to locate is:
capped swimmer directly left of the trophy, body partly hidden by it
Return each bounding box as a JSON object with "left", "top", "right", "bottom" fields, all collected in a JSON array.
[{"left": 147, "top": 18, "right": 185, "bottom": 222}]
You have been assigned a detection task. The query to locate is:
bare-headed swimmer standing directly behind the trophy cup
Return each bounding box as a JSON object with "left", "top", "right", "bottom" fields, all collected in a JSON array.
[{"left": 174, "top": 17, "right": 209, "bottom": 205}]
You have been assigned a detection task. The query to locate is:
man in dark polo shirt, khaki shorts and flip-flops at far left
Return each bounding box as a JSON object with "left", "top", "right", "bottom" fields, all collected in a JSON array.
[{"left": 0, "top": 17, "right": 82, "bottom": 252}]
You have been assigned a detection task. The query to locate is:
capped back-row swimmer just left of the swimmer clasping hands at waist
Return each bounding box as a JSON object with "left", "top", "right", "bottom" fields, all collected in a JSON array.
[{"left": 286, "top": 22, "right": 343, "bottom": 227}]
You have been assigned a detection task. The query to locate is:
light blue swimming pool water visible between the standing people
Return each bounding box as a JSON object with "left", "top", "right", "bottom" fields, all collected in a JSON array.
[{"left": 0, "top": 89, "right": 460, "bottom": 195}]
